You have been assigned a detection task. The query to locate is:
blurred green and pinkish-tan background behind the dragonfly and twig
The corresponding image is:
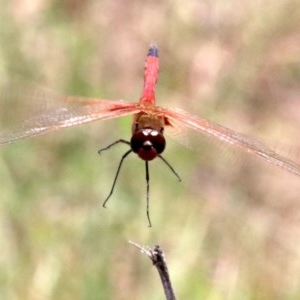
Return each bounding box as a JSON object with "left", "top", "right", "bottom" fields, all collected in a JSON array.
[{"left": 0, "top": 0, "right": 300, "bottom": 300}]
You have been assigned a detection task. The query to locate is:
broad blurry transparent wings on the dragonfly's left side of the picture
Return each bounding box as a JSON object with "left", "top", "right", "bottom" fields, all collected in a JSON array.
[{"left": 0, "top": 88, "right": 139, "bottom": 144}]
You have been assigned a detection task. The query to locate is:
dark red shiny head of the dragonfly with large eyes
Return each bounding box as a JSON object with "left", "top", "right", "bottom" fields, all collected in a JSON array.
[{"left": 130, "top": 128, "right": 166, "bottom": 161}]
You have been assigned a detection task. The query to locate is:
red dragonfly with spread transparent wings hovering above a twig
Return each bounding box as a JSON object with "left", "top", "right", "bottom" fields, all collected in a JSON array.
[{"left": 0, "top": 43, "right": 300, "bottom": 226}]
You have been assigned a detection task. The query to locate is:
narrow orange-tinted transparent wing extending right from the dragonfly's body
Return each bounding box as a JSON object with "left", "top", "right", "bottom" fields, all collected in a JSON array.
[{"left": 159, "top": 108, "right": 300, "bottom": 176}]
